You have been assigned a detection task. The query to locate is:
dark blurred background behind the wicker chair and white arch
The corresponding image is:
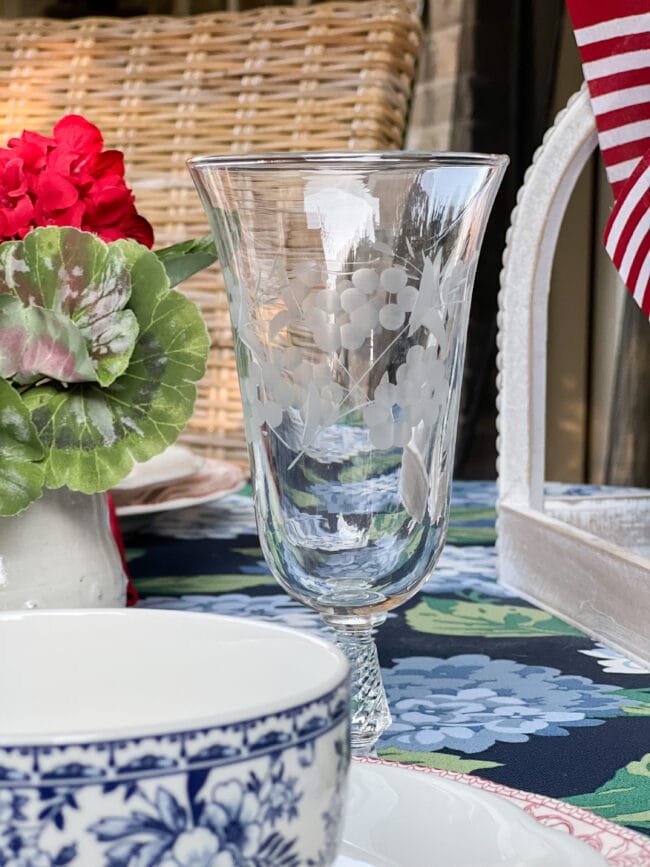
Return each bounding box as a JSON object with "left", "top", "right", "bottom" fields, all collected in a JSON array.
[{"left": 0, "top": 0, "right": 650, "bottom": 487}]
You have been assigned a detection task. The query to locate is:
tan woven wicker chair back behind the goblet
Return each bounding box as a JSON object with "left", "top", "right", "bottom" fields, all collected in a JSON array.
[{"left": 0, "top": 0, "right": 420, "bottom": 463}]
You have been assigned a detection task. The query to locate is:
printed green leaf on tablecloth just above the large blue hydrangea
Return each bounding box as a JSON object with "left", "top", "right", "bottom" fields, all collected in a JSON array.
[{"left": 406, "top": 597, "right": 583, "bottom": 638}]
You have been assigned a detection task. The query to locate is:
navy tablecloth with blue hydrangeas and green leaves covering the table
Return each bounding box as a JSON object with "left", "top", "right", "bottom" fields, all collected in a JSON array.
[{"left": 122, "top": 482, "right": 650, "bottom": 835}]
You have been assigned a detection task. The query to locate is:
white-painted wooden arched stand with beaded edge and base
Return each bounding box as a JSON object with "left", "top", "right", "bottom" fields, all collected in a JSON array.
[{"left": 497, "top": 86, "right": 650, "bottom": 665}]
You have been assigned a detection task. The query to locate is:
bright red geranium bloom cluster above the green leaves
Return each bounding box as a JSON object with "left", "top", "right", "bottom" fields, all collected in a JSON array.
[{"left": 0, "top": 114, "right": 153, "bottom": 247}]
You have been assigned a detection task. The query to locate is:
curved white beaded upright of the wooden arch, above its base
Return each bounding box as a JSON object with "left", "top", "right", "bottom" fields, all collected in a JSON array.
[{"left": 497, "top": 85, "right": 597, "bottom": 508}]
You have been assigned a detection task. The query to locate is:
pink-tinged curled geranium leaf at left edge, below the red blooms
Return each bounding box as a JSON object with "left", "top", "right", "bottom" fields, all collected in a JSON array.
[{"left": 0, "top": 295, "right": 97, "bottom": 384}]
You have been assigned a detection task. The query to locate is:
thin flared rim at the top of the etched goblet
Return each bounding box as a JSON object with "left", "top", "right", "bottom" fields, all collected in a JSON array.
[{"left": 186, "top": 150, "right": 510, "bottom": 171}]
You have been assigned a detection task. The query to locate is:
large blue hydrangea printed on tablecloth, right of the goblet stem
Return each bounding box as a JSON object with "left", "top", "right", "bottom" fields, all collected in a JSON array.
[{"left": 380, "top": 654, "right": 634, "bottom": 753}]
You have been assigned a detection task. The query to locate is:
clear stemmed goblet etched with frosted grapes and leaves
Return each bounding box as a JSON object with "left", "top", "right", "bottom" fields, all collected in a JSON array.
[{"left": 188, "top": 152, "right": 507, "bottom": 755}]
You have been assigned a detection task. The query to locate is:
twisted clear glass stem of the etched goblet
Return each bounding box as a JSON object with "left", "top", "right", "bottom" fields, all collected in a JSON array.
[{"left": 323, "top": 615, "right": 392, "bottom": 756}]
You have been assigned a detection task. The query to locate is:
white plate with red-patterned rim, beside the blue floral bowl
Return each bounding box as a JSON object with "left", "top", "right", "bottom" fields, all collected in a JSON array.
[{"left": 334, "top": 760, "right": 650, "bottom": 867}]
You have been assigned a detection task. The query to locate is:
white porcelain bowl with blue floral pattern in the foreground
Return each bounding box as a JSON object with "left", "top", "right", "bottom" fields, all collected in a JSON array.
[{"left": 0, "top": 609, "right": 349, "bottom": 867}]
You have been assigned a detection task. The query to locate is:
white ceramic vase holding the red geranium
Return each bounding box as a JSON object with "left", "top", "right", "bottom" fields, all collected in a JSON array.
[{"left": 0, "top": 488, "right": 127, "bottom": 610}]
